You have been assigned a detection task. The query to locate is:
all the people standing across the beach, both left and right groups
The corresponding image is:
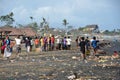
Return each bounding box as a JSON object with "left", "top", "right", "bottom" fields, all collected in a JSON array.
[{"left": 1, "top": 35, "right": 99, "bottom": 60}]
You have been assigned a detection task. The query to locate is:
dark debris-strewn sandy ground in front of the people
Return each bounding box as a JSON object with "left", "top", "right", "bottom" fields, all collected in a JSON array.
[{"left": 0, "top": 42, "right": 120, "bottom": 80}]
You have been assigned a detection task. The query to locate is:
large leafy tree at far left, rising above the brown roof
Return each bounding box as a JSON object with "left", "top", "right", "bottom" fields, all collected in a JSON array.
[{"left": 0, "top": 12, "right": 15, "bottom": 26}]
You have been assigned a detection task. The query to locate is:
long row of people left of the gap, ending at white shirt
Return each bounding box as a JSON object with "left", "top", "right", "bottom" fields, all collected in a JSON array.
[{"left": 0, "top": 35, "right": 72, "bottom": 58}]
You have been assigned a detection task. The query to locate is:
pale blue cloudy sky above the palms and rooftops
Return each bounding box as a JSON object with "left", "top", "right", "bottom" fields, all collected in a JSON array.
[{"left": 0, "top": 0, "right": 120, "bottom": 30}]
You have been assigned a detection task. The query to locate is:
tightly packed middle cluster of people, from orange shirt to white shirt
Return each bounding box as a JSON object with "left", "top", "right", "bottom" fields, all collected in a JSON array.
[{"left": 31, "top": 35, "right": 72, "bottom": 51}]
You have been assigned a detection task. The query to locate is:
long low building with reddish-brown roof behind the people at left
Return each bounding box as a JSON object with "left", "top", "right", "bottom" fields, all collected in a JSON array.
[{"left": 0, "top": 26, "right": 37, "bottom": 38}]
